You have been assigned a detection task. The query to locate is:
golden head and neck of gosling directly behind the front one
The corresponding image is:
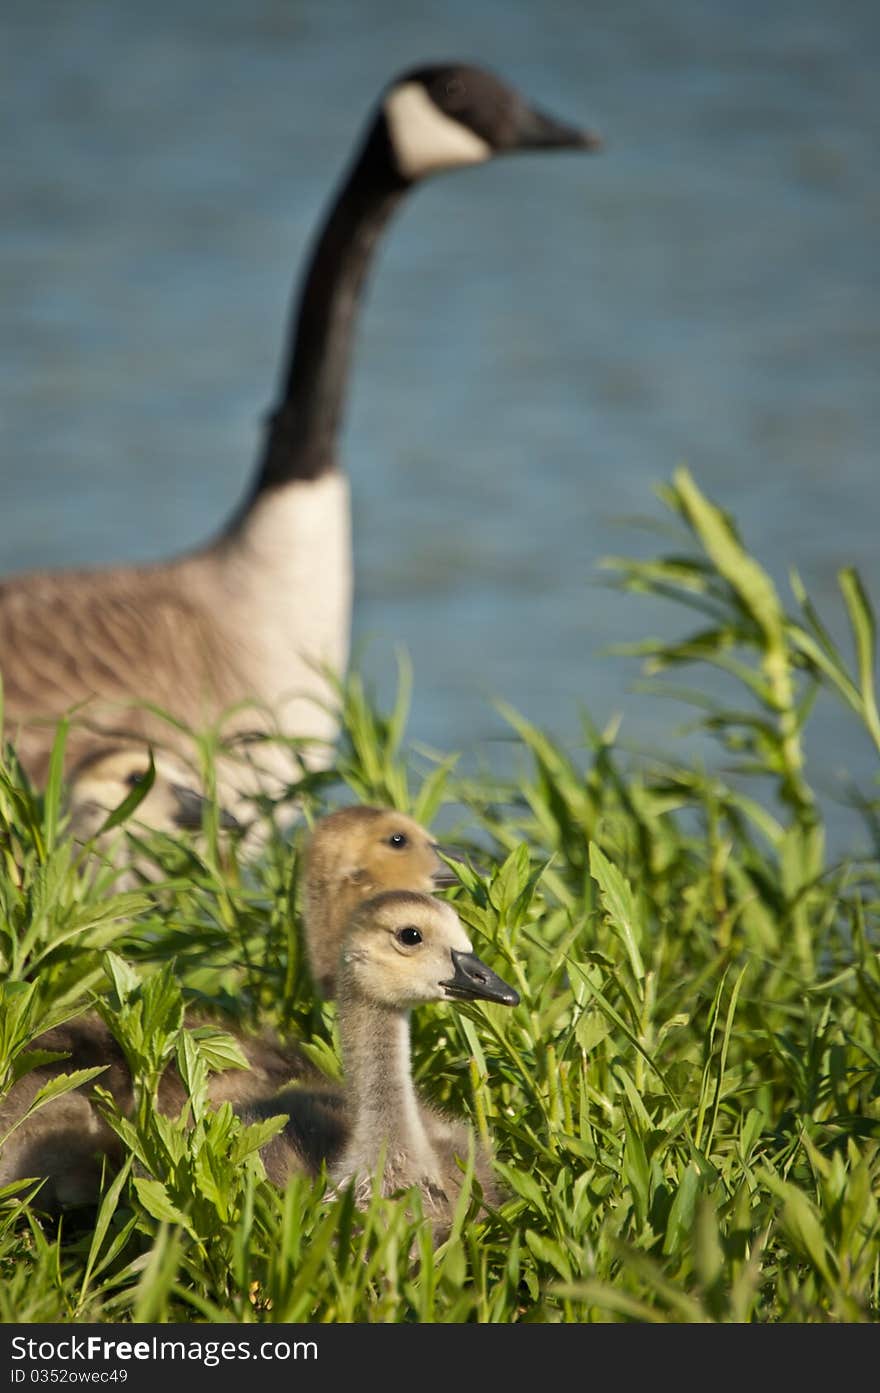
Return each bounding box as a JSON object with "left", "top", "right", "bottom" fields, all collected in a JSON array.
[{"left": 302, "top": 805, "right": 461, "bottom": 996}]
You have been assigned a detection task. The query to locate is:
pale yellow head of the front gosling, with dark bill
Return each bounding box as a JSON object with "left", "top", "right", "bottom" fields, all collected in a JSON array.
[{"left": 338, "top": 890, "right": 519, "bottom": 1011}]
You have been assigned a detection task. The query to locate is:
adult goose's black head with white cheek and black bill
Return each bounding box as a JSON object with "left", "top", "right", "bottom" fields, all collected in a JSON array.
[{"left": 379, "top": 63, "right": 600, "bottom": 182}]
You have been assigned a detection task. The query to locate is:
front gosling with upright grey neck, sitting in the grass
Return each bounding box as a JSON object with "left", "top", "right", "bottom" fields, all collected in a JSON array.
[{"left": 241, "top": 890, "right": 519, "bottom": 1229}]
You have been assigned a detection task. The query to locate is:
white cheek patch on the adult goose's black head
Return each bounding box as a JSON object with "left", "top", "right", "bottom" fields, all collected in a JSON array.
[{"left": 384, "top": 82, "right": 492, "bottom": 178}]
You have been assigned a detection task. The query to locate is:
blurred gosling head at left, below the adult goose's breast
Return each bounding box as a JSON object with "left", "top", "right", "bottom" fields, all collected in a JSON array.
[{"left": 68, "top": 745, "right": 239, "bottom": 841}]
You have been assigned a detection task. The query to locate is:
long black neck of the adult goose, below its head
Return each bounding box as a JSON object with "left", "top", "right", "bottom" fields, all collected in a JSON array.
[{"left": 255, "top": 116, "right": 409, "bottom": 496}]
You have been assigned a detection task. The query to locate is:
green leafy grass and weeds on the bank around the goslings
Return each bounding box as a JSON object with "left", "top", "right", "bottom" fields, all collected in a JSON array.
[{"left": 0, "top": 471, "right": 880, "bottom": 1323}]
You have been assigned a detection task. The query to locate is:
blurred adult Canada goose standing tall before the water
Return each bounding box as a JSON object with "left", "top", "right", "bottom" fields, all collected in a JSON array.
[{"left": 0, "top": 64, "right": 597, "bottom": 811}]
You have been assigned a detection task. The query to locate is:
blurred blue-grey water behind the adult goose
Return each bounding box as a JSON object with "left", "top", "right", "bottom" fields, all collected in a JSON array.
[{"left": 0, "top": 0, "right": 880, "bottom": 852}]
